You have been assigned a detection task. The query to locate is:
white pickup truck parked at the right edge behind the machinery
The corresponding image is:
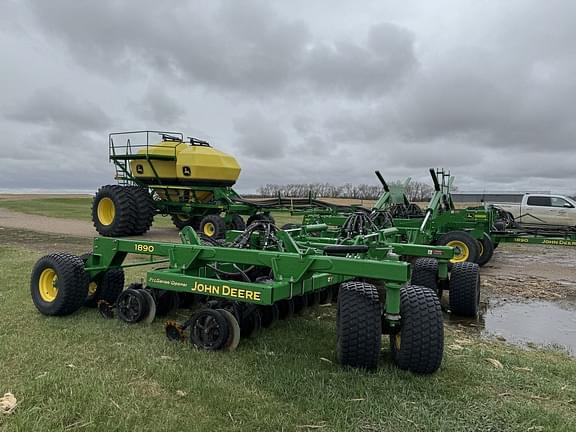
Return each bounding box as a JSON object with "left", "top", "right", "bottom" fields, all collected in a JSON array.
[{"left": 493, "top": 194, "right": 576, "bottom": 227}]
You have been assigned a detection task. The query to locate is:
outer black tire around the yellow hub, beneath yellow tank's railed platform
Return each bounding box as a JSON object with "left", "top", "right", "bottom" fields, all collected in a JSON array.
[{"left": 92, "top": 185, "right": 138, "bottom": 237}]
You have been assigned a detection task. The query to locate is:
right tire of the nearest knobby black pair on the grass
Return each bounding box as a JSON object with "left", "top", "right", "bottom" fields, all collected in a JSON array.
[{"left": 390, "top": 285, "right": 444, "bottom": 374}]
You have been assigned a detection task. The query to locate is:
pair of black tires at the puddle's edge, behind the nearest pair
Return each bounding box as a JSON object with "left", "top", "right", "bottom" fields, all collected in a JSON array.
[{"left": 411, "top": 258, "right": 480, "bottom": 318}]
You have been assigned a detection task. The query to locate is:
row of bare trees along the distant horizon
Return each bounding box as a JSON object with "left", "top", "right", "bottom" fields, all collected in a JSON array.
[{"left": 257, "top": 181, "right": 434, "bottom": 201}]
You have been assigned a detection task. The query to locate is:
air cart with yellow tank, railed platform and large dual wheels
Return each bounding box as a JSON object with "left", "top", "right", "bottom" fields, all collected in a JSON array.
[{"left": 92, "top": 131, "right": 364, "bottom": 238}]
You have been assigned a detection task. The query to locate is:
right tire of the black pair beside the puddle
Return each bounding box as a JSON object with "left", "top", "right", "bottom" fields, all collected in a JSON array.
[{"left": 449, "top": 262, "right": 480, "bottom": 317}]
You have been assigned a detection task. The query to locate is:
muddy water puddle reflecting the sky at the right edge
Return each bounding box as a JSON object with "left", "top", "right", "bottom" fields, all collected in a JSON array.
[{"left": 446, "top": 299, "right": 576, "bottom": 357}]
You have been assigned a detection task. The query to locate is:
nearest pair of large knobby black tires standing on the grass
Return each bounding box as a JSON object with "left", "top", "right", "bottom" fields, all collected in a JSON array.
[{"left": 336, "top": 282, "right": 444, "bottom": 374}]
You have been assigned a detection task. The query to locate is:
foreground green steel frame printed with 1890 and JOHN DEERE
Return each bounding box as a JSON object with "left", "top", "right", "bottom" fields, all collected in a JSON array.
[{"left": 85, "top": 226, "right": 453, "bottom": 327}]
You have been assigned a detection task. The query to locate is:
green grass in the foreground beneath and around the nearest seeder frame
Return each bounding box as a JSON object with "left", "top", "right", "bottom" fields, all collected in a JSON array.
[{"left": 0, "top": 235, "right": 576, "bottom": 431}]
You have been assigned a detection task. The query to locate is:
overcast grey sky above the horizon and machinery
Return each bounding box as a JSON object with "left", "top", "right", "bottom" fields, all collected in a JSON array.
[{"left": 0, "top": 0, "right": 576, "bottom": 193}]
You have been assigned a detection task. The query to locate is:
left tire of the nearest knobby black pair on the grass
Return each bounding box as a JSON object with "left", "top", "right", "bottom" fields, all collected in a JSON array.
[{"left": 336, "top": 282, "right": 382, "bottom": 370}]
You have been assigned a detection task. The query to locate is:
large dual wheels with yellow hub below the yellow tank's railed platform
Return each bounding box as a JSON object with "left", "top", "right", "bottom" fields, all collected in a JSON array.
[{"left": 92, "top": 185, "right": 156, "bottom": 237}]
